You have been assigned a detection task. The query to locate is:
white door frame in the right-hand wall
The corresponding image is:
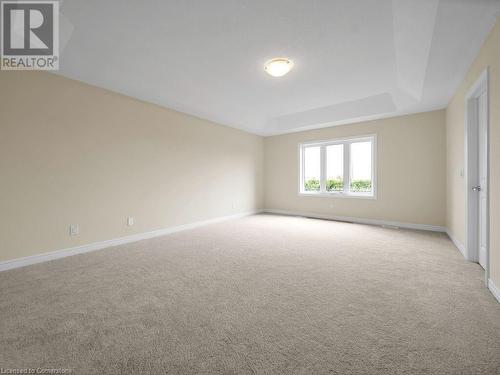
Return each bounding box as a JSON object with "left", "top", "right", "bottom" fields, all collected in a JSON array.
[{"left": 464, "top": 67, "right": 490, "bottom": 285}]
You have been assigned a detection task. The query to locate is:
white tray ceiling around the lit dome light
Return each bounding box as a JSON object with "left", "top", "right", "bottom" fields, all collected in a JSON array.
[{"left": 56, "top": 0, "right": 500, "bottom": 135}]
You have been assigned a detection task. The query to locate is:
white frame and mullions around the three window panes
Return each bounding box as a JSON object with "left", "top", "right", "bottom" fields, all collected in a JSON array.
[{"left": 298, "top": 134, "right": 377, "bottom": 199}]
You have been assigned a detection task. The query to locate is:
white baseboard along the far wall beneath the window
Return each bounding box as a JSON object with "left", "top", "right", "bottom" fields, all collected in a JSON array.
[{"left": 264, "top": 209, "right": 446, "bottom": 232}]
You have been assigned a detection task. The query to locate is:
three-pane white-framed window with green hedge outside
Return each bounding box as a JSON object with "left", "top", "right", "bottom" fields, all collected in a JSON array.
[{"left": 300, "top": 136, "right": 376, "bottom": 198}]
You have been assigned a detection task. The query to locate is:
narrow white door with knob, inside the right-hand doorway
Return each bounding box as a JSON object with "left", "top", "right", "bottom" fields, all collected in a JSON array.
[{"left": 477, "top": 93, "right": 488, "bottom": 268}]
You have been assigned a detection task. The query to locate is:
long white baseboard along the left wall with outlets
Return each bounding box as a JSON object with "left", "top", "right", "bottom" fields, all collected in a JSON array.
[{"left": 0, "top": 210, "right": 263, "bottom": 271}]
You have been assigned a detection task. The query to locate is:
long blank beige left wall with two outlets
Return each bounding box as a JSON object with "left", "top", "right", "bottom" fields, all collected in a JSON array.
[{"left": 0, "top": 72, "right": 263, "bottom": 261}]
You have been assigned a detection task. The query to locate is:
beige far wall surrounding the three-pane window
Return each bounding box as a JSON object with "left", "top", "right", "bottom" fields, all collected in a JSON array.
[{"left": 264, "top": 110, "right": 446, "bottom": 226}]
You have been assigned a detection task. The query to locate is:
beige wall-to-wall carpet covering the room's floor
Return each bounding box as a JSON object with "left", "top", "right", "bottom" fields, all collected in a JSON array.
[{"left": 0, "top": 215, "right": 500, "bottom": 375}]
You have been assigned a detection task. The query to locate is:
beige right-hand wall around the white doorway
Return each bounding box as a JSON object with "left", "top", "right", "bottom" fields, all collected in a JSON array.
[{"left": 446, "top": 20, "right": 500, "bottom": 286}]
